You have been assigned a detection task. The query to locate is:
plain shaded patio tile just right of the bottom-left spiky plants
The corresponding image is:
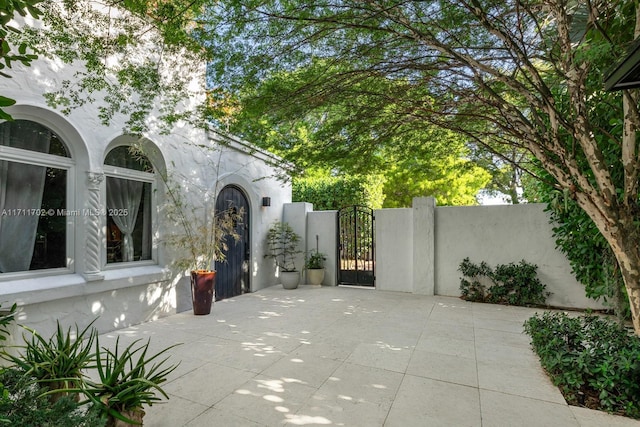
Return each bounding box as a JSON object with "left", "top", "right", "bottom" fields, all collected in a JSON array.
[{"left": 163, "top": 363, "right": 255, "bottom": 407}]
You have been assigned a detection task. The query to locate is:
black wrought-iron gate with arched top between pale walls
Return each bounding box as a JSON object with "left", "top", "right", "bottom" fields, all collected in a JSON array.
[{"left": 337, "top": 205, "right": 375, "bottom": 286}]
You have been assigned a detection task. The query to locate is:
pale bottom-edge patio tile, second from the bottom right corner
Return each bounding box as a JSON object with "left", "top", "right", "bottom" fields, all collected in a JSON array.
[{"left": 480, "top": 389, "right": 580, "bottom": 427}]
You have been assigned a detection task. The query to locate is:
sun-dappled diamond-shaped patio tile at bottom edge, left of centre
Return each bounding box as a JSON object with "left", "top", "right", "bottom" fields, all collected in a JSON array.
[{"left": 215, "top": 375, "right": 317, "bottom": 426}]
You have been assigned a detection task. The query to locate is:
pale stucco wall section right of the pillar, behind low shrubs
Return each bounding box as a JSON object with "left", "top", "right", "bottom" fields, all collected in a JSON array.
[{"left": 435, "top": 204, "right": 601, "bottom": 308}]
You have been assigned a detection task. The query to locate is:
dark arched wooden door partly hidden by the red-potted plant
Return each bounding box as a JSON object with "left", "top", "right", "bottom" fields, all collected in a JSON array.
[{"left": 216, "top": 186, "right": 251, "bottom": 301}]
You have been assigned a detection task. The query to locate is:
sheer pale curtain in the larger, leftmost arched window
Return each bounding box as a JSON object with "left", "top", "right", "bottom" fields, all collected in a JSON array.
[{"left": 0, "top": 122, "right": 51, "bottom": 273}]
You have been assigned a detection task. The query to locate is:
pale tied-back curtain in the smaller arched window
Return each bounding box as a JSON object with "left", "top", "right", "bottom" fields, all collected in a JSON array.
[{"left": 107, "top": 177, "right": 144, "bottom": 262}]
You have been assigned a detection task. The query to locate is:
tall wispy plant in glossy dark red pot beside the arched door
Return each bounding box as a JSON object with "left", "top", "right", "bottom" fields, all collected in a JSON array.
[{"left": 163, "top": 175, "right": 244, "bottom": 315}]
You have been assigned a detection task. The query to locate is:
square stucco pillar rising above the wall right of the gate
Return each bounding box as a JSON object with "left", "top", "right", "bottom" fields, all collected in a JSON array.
[{"left": 413, "top": 197, "right": 436, "bottom": 295}]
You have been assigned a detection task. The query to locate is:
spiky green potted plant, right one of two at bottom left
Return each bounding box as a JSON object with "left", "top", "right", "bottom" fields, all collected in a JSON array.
[{"left": 80, "top": 337, "right": 178, "bottom": 423}]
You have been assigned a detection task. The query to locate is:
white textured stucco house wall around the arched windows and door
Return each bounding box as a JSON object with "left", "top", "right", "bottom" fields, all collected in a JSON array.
[{"left": 0, "top": 11, "right": 291, "bottom": 332}]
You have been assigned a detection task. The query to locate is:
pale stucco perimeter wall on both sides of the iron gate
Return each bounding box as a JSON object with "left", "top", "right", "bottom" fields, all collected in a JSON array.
[{"left": 292, "top": 198, "right": 603, "bottom": 309}]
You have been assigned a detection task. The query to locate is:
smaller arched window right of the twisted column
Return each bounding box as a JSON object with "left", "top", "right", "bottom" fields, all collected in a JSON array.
[{"left": 104, "top": 146, "right": 155, "bottom": 263}]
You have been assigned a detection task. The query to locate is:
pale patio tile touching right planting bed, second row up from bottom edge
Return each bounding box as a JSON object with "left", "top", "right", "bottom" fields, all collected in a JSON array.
[{"left": 478, "top": 362, "right": 565, "bottom": 404}]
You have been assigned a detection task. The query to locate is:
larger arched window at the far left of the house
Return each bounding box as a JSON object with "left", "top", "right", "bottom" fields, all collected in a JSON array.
[{"left": 0, "top": 120, "right": 73, "bottom": 273}]
